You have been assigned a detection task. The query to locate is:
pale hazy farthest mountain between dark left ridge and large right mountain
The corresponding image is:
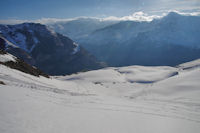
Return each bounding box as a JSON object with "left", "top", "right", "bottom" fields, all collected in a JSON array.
[{"left": 48, "top": 17, "right": 118, "bottom": 42}]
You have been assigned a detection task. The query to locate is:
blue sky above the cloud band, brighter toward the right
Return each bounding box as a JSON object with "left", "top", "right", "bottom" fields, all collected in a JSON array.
[{"left": 0, "top": 0, "right": 200, "bottom": 20}]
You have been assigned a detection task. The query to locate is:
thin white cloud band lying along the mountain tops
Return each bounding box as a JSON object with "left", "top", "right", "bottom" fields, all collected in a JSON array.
[{"left": 0, "top": 10, "right": 200, "bottom": 25}]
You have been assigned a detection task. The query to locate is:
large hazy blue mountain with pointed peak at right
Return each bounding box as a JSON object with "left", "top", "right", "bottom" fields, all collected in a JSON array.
[{"left": 65, "top": 12, "right": 200, "bottom": 66}]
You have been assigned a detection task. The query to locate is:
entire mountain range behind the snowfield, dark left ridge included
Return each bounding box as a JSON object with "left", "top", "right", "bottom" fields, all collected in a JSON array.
[{"left": 0, "top": 12, "right": 200, "bottom": 75}]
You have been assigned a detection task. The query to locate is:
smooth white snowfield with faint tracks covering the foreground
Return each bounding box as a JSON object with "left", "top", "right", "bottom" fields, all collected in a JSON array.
[{"left": 0, "top": 60, "right": 200, "bottom": 133}]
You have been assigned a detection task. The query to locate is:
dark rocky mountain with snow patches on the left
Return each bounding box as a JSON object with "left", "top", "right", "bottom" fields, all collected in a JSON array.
[{"left": 0, "top": 23, "right": 102, "bottom": 75}]
